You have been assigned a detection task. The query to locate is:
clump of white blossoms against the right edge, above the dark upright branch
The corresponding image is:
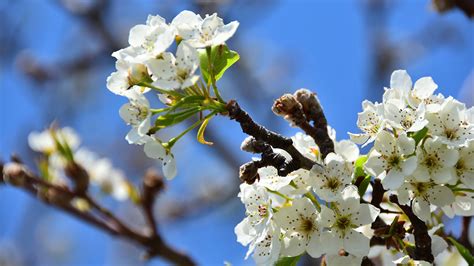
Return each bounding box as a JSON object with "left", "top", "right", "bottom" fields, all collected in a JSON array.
[{"left": 351, "top": 70, "right": 474, "bottom": 222}]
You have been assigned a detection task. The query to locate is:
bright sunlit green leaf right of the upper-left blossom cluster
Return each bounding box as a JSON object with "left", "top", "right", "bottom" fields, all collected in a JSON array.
[{"left": 199, "top": 44, "right": 240, "bottom": 84}]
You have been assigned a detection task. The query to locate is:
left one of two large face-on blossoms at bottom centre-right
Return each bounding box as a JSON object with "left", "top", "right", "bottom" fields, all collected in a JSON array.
[{"left": 275, "top": 198, "right": 323, "bottom": 258}]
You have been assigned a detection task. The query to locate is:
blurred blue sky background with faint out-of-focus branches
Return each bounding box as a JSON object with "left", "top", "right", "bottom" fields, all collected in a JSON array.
[{"left": 0, "top": 0, "right": 474, "bottom": 266}]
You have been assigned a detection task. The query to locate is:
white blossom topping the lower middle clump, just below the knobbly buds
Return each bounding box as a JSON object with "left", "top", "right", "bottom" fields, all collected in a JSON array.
[{"left": 310, "top": 153, "right": 352, "bottom": 202}]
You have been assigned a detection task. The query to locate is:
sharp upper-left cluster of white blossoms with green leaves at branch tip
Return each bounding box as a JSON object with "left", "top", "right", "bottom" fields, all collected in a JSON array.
[{"left": 107, "top": 11, "right": 239, "bottom": 178}]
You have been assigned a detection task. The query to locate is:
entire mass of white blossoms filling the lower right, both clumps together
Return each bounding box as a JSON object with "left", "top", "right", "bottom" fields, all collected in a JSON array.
[{"left": 235, "top": 70, "right": 474, "bottom": 265}]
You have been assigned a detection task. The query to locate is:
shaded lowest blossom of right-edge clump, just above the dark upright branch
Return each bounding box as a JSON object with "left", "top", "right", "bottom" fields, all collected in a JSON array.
[{"left": 397, "top": 180, "right": 454, "bottom": 221}]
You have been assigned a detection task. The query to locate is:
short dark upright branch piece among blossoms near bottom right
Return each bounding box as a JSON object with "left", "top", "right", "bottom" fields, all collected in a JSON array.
[{"left": 390, "top": 195, "right": 434, "bottom": 263}]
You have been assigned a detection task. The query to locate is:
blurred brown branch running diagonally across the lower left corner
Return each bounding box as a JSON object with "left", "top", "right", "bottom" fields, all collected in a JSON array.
[{"left": 0, "top": 160, "right": 195, "bottom": 265}]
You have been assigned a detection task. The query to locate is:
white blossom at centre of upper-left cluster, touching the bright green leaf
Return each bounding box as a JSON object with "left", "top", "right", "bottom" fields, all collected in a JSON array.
[{"left": 147, "top": 42, "right": 199, "bottom": 90}]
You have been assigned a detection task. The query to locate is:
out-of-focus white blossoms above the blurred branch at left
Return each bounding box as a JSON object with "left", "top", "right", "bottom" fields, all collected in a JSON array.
[{"left": 28, "top": 127, "right": 133, "bottom": 201}]
